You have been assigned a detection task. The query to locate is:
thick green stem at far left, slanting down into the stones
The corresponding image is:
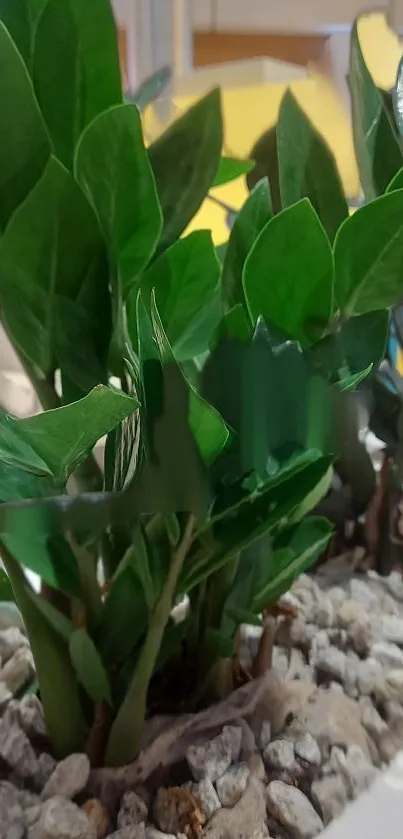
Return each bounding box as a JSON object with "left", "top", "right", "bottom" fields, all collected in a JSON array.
[{"left": 2, "top": 552, "right": 87, "bottom": 759}]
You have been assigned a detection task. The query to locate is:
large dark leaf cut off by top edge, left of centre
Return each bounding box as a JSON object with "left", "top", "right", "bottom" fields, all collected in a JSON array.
[{"left": 34, "top": 0, "right": 122, "bottom": 168}]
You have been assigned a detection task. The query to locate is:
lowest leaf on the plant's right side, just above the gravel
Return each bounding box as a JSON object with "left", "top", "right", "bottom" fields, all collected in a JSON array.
[{"left": 253, "top": 516, "right": 333, "bottom": 613}]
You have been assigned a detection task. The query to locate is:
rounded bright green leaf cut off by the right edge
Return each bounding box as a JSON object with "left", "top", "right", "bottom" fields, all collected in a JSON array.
[{"left": 334, "top": 190, "right": 403, "bottom": 315}]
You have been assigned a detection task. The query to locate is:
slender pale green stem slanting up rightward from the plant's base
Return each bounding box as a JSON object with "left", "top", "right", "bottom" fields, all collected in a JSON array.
[{"left": 106, "top": 513, "right": 195, "bottom": 766}]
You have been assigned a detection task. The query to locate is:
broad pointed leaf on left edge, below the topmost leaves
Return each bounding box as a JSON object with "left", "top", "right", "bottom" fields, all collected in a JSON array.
[{"left": 0, "top": 157, "right": 108, "bottom": 373}]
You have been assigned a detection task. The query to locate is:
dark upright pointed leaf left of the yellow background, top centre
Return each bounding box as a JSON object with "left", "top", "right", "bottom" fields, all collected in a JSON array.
[{"left": 148, "top": 89, "right": 223, "bottom": 251}]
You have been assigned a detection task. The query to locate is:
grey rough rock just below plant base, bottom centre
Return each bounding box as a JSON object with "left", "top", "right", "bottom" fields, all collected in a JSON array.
[{"left": 186, "top": 726, "right": 242, "bottom": 781}]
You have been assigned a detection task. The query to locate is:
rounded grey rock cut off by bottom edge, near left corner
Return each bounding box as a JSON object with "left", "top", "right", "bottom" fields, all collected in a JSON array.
[{"left": 35, "top": 796, "right": 95, "bottom": 839}]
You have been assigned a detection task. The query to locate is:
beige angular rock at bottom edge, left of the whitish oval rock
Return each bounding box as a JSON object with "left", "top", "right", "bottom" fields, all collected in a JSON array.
[{"left": 203, "top": 777, "right": 269, "bottom": 839}]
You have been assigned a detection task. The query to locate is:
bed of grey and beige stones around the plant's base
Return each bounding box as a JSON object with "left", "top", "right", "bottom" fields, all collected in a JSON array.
[{"left": 0, "top": 561, "right": 403, "bottom": 839}]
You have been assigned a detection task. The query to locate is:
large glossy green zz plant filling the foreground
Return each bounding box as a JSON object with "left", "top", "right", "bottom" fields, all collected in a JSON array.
[{"left": 0, "top": 0, "right": 403, "bottom": 776}]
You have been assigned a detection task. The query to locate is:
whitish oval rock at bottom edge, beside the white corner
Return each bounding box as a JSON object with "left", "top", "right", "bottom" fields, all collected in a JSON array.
[{"left": 266, "top": 781, "right": 323, "bottom": 839}]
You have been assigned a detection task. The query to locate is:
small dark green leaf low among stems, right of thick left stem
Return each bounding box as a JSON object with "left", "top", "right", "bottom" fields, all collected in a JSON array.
[{"left": 69, "top": 629, "right": 112, "bottom": 705}]
